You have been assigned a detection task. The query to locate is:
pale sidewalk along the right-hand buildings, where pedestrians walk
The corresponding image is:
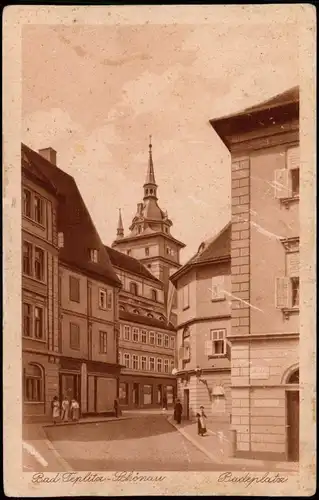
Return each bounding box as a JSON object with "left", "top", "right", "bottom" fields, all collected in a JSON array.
[{"left": 167, "top": 417, "right": 299, "bottom": 472}]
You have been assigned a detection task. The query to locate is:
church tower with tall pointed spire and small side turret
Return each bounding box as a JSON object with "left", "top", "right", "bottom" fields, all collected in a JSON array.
[{"left": 112, "top": 137, "right": 185, "bottom": 291}]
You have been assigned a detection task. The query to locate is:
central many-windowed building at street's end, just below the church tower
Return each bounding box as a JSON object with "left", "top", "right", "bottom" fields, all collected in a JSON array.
[{"left": 106, "top": 247, "right": 176, "bottom": 409}]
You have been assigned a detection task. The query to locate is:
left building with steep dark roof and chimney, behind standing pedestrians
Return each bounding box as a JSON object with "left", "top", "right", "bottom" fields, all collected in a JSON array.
[{"left": 24, "top": 147, "right": 121, "bottom": 414}]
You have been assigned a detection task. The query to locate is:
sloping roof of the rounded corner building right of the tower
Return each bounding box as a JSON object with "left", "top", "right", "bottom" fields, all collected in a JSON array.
[{"left": 170, "top": 222, "right": 231, "bottom": 282}]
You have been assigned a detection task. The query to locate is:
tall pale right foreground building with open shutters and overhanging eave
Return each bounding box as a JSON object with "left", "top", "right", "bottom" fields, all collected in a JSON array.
[{"left": 211, "top": 88, "right": 300, "bottom": 460}]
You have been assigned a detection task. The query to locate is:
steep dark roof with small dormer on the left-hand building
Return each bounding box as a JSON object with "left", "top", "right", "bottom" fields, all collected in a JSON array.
[{"left": 21, "top": 144, "right": 121, "bottom": 287}]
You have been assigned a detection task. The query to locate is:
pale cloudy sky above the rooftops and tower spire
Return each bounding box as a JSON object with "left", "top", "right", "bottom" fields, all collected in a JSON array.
[{"left": 22, "top": 12, "right": 299, "bottom": 263}]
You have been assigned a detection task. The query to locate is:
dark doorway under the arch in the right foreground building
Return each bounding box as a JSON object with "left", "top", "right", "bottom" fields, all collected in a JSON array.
[{"left": 286, "top": 391, "right": 299, "bottom": 462}]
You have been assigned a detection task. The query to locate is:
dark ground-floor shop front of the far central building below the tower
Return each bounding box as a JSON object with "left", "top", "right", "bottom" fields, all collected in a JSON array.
[{"left": 119, "top": 375, "right": 176, "bottom": 410}]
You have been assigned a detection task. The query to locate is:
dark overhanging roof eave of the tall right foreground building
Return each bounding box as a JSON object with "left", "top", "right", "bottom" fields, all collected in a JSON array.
[{"left": 209, "top": 87, "right": 299, "bottom": 149}]
